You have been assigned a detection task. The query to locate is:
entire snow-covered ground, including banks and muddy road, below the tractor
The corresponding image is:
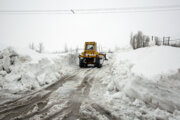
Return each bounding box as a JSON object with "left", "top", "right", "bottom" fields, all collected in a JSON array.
[{"left": 0, "top": 46, "right": 180, "bottom": 120}]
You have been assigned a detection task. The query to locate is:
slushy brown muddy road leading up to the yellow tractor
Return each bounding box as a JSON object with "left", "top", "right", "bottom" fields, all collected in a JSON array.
[{"left": 0, "top": 68, "right": 117, "bottom": 120}]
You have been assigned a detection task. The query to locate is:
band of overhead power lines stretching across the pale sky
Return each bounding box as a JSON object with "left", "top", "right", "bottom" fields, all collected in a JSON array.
[{"left": 0, "top": 5, "right": 180, "bottom": 14}]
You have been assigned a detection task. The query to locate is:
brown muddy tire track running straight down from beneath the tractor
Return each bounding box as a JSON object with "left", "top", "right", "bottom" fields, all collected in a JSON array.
[{"left": 45, "top": 71, "right": 94, "bottom": 120}]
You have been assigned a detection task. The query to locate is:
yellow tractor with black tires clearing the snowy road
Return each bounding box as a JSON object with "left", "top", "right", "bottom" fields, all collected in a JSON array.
[{"left": 79, "top": 42, "right": 106, "bottom": 68}]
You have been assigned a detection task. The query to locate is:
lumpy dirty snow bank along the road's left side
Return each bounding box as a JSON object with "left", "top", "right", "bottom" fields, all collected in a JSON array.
[{"left": 0, "top": 47, "right": 77, "bottom": 102}]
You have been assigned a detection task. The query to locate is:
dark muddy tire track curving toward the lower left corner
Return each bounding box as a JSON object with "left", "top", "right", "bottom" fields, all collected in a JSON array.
[{"left": 0, "top": 74, "right": 80, "bottom": 120}]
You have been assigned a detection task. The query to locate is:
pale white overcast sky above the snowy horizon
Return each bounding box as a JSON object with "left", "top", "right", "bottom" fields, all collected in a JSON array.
[{"left": 0, "top": 0, "right": 180, "bottom": 51}]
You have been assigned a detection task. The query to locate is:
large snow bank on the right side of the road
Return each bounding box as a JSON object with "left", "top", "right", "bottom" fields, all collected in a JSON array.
[{"left": 103, "top": 46, "right": 180, "bottom": 112}]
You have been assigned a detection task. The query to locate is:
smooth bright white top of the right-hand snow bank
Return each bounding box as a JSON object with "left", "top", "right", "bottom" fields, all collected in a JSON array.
[{"left": 119, "top": 46, "right": 180, "bottom": 78}]
